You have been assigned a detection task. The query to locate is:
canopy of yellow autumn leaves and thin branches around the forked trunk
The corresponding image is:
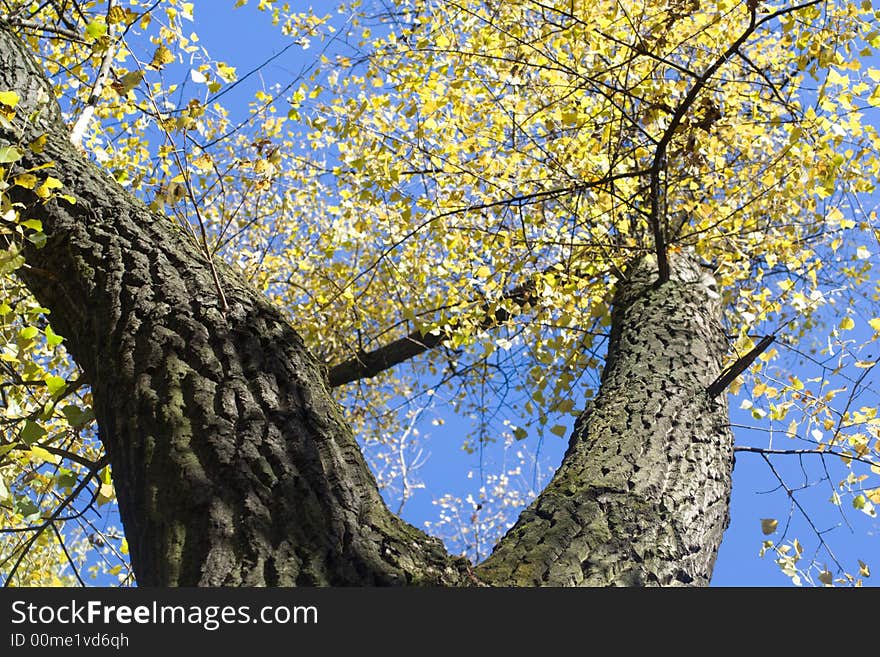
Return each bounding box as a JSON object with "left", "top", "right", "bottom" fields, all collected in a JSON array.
[{"left": 0, "top": 0, "right": 880, "bottom": 585}]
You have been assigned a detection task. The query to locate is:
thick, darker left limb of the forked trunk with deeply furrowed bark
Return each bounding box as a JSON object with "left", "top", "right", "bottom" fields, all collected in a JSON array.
[{"left": 0, "top": 25, "right": 468, "bottom": 586}]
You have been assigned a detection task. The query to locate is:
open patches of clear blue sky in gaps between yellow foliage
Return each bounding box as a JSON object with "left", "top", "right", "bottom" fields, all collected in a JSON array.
[{"left": 101, "top": 0, "right": 880, "bottom": 586}]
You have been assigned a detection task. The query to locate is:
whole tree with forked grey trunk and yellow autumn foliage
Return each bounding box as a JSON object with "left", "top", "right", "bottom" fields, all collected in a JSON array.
[{"left": 0, "top": 0, "right": 880, "bottom": 585}]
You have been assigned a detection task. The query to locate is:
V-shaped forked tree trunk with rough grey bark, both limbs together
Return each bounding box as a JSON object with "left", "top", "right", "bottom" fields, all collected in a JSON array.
[{"left": 0, "top": 24, "right": 731, "bottom": 586}]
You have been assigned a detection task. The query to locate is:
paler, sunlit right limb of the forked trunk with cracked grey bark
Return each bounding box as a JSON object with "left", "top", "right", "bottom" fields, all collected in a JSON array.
[{"left": 477, "top": 256, "right": 733, "bottom": 586}]
